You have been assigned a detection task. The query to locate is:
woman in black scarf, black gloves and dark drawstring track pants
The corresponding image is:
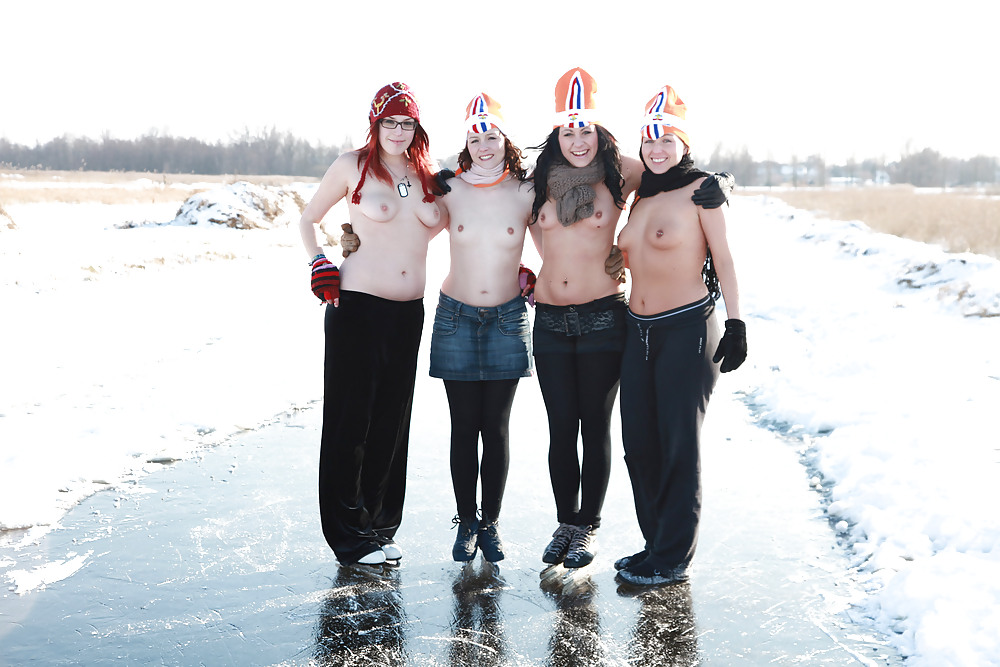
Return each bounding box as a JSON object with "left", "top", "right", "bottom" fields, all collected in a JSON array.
[{"left": 615, "top": 86, "right": 747, "bottom": 585}]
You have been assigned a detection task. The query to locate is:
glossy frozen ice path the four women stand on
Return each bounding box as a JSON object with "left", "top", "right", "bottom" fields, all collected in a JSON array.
[{"left": 0, "top": 404, "right": 898, "bottom": 665}]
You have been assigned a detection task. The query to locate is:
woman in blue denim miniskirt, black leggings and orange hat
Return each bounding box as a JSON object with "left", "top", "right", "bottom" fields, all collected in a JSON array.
[{"left": 430, "top": 93, "right": 536, "bottom": 562}]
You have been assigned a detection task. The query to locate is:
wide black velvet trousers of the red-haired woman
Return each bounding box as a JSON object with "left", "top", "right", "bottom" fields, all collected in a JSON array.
[{"left": 319, "top": 291, "right": 424, "bottom": 563}]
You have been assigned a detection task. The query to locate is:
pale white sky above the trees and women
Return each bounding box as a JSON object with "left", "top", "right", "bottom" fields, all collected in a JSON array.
[{"left": 0, "top": 0, "right": 1000, "bottom": 163}]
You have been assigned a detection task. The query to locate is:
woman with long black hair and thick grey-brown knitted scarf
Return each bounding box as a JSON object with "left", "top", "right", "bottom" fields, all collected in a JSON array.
[{"left": 532, "top": 68, "right": 725, "bottom": 568}]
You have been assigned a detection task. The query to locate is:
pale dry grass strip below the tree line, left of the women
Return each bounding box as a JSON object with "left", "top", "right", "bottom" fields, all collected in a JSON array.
[{"left": 0, "top": 169, "right": 316, "bottom": 206}]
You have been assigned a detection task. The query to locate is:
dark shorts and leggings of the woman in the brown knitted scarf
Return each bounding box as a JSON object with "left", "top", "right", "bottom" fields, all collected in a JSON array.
[{"left": 533, "top": 295, "right": 625, "bottom": 528}]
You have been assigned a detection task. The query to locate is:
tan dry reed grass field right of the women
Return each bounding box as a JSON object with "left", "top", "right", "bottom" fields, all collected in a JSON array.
[{"left": 767, "top": 185, "right": 1000, "bottom": 257}]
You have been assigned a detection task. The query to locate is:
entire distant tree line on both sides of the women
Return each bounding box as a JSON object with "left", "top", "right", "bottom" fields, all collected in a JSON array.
[{"left": 0, "top": 128, "right": 1000, "bottom": 187}]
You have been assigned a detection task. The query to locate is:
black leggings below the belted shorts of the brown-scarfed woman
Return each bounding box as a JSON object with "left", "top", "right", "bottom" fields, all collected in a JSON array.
[{"left": 535, "top": 352, "right": 622, "bottom": 528}]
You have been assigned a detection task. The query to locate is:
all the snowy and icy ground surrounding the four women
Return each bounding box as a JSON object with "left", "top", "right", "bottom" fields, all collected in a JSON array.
[{"left": 0, "top": 186, "right": 1000, "bottom": 667}]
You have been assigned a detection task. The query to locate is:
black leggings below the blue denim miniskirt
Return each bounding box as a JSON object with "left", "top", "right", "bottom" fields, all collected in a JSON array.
[{"left": 444, "top": 378, "right": 517, "bottom": 521}]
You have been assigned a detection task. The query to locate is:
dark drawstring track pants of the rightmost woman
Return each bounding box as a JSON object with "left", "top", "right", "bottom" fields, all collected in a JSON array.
[{"left": 621, "top": 297, "right": 720, "bottom": 569}]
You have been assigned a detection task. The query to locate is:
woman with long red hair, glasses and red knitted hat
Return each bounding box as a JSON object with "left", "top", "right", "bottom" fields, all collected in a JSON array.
[{"left": 299, "top": 82, "right": 447, "bottom": 565}]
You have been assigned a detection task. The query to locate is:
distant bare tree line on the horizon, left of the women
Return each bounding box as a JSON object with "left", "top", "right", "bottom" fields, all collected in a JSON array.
[{"left": 0, "top": 129, "right": 341, "bottom": 176}]
